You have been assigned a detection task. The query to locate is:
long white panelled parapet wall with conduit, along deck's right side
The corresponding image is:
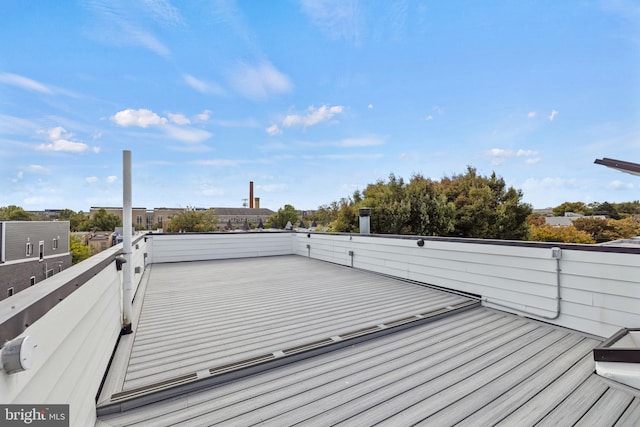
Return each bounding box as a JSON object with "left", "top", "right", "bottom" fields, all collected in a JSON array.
[{"left": 294, "top": 233, "right": 640, "bottom": 337}]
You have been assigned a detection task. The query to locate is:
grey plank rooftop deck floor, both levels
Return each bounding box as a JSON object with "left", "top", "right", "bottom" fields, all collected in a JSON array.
[{"left": 98, "top": 256, "right": 640, "bottom": 426}]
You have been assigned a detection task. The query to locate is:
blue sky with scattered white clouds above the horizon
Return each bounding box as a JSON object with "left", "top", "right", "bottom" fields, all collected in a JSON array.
[{"left": 0, "top": 0, "right": 640, "bottom": 212}]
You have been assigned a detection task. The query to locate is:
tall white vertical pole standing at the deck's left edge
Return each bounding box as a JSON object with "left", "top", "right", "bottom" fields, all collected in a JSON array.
[{"left": 122, "top": 150, "right": 133, "bottom": 334}]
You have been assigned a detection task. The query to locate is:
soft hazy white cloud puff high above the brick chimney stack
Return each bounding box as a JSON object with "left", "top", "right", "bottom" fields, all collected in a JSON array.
[{"left": 228, "top": 62, "right": 293, "bottom": 100}]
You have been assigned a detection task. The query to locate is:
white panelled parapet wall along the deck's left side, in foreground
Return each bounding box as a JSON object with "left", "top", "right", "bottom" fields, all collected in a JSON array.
[{"left": 0, "top": 239, "right": 146, "bottom": 426}]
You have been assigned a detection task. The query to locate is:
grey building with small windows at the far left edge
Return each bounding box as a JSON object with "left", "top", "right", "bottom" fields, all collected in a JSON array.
[{"left": 0, "top": 221, "right": 72, "bottom": 300}]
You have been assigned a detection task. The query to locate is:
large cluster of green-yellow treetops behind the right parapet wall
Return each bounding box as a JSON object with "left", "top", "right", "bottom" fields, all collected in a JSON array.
[{"left": 315, "top": 167, "right": 532, "bottom": 239}]
